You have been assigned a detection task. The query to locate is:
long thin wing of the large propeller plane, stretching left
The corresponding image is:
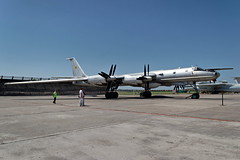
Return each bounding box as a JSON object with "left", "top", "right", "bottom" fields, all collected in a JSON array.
[{"left": 4, "top": 77, "right": 88, "bottom": 85}]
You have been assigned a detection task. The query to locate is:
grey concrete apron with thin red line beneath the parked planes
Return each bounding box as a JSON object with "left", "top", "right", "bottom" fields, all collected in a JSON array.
[{"left": 0, "top": 94, "right": 240, "bottom": 160}]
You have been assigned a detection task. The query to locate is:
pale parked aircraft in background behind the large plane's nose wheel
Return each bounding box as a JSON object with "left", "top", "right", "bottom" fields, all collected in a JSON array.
[{"left": 188, "top": 80, "right": 240, "bottom": 94}]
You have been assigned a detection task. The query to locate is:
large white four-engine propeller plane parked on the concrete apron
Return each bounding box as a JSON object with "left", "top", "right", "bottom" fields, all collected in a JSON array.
[{"left": 6, "top": 58, "right": 232, "bottom": 99}]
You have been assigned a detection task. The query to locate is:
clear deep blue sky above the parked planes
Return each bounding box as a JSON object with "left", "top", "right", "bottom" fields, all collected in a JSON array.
[{"left": 0, "top": 0, "right": 240, "bottom": 82}]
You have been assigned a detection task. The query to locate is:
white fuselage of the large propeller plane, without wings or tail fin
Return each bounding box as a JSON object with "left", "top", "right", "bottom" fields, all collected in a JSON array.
[{"left": 79, "top": 67, "right": 220, "bottom": 88}]
